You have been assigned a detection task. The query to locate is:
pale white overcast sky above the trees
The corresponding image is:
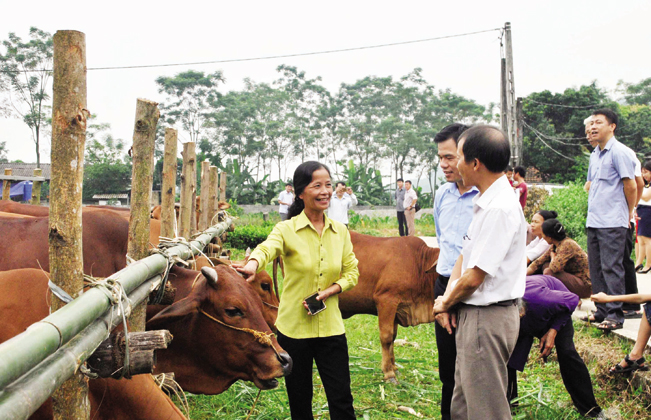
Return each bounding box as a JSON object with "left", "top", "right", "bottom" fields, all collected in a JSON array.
[{"left": 0, "top": 0, "right": 651, "bottom": 181}]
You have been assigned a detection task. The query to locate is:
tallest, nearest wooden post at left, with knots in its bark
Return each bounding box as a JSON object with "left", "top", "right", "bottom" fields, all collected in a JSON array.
[{"left": 49, "top": 31, "right": 90, "bottom": 419}]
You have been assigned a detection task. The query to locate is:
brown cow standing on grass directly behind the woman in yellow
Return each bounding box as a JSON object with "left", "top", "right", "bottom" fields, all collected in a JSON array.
[{"left": 339, "top": 232, "right": 439, "bottom": 383}]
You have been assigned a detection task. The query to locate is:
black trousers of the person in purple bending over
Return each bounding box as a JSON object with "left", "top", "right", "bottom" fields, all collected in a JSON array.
[{"left": 507, "top": 321, "right": 601, "bottom": 417}]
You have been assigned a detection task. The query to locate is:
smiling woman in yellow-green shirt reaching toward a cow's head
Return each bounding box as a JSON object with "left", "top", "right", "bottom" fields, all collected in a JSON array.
[{"left": 236, "top": 161, "right": 359, "bottom": 420}]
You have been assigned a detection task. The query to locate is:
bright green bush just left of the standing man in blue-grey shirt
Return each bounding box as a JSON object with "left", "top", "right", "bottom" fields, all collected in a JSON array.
[{"left": 543, "top": 183, "right": 588, "bottom": 249}]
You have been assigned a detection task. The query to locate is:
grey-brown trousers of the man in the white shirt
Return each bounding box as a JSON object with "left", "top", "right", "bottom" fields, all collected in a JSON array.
[{"left": 451, "top": 304, "right": 520, "bottom": 420}]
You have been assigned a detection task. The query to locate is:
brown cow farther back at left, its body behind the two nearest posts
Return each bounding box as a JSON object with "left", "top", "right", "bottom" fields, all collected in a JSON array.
[{"left": 0, "top": 210, "right": 129, "bottom": 277}]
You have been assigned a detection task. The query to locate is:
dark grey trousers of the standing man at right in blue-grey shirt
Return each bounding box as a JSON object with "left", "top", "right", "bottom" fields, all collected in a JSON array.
[{"left": 588, "top": 227, "right": 628, "bottom": 322}]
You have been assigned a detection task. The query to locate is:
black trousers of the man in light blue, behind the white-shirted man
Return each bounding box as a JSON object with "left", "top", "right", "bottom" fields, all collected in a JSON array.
[{"left": 434, "top": 275, "right": 457, "bottom": 420}]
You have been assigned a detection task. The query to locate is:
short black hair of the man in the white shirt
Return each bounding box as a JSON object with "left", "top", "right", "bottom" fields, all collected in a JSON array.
[{"left": 459, "top": 124, "right": 511, "bottom": 173}]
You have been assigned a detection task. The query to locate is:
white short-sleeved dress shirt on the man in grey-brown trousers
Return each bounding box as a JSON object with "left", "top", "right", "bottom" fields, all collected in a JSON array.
[{"left": 452, "top": 176, "right": 527, "bottom": 306}]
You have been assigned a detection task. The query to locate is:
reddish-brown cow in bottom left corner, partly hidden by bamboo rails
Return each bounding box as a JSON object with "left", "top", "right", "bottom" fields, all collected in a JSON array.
[{"left": 0, "top": 269, "right": 185, "bottom": 420}]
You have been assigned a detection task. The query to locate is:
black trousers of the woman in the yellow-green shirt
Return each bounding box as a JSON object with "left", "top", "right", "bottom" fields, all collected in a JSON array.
[{"left": 278, "top": 331, "right": 355, "bottom": 420}]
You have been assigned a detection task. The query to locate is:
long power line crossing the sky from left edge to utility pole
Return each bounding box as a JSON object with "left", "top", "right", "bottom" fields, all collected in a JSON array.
[{"left": 0, "top": 28, "right": 502, "bottom": 73}]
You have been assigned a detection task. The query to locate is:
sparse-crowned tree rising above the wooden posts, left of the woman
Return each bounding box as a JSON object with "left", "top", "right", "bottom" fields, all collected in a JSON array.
[{"left": 156, "top": 70, "right": 225, "bottom": 143}]
